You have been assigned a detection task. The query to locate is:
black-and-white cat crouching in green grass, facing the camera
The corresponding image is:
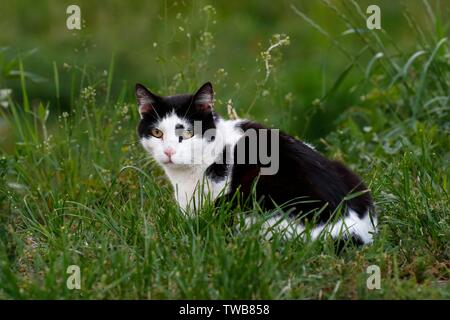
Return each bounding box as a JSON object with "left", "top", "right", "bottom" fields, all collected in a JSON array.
[{"left": 136, "top": 82, "right": 377, "bottom": 245}]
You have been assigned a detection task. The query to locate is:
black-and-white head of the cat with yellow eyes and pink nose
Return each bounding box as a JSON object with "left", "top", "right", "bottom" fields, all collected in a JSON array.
[{"left": 136, "top": 82, "right": 218, "bottom": 169}]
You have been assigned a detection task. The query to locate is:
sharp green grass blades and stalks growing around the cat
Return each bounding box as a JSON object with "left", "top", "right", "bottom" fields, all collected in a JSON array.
[{"left": 0, "top": 1, "right": 450, "bottom": 299}]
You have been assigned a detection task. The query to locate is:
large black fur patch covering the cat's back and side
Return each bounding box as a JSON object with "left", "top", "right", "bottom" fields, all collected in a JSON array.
[{"left": 231, "top": 122, "right": 372, "bottom": 222}]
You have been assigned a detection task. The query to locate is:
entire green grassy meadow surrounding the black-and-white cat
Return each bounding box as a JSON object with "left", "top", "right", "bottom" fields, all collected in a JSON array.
[{"left": 0, "top": 0, "right": 450, "bottom": 299}]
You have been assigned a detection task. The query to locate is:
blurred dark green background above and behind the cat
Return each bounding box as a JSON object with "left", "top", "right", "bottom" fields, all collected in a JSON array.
[{"left": 0, "top": 0, "right": 448, "bottom": 140}]
